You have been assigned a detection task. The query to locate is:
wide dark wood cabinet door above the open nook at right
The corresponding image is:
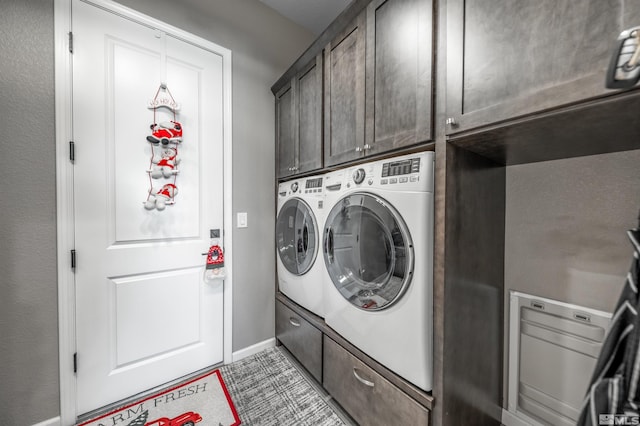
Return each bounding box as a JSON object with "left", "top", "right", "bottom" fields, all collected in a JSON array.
[{"left": 446, "top": 0, "right": 640, "bottom": 133}]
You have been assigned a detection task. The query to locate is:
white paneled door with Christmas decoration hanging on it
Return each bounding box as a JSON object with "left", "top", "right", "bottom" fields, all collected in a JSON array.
[{"left": 72, "top": 0, "right": 224, "bottom": 414}]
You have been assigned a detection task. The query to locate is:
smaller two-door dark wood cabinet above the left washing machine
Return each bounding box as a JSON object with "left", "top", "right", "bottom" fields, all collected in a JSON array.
[{"left": 276, "top": 54, "right": 323, "bottom": 178}]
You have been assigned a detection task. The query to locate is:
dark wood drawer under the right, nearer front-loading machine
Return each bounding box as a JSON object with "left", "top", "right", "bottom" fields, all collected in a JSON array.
[{"left": 322, "top": 336, "right": 429, "bottom": 426}]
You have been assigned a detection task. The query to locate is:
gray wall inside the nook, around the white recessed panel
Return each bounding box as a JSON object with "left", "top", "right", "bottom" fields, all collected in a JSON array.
[{"left": 504, "top": 150, "right": 640, "bottom": 407}]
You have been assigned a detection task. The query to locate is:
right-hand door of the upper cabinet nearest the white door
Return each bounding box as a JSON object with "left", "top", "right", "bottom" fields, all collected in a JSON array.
[{"left": 296, "top": 54, "right": 322, "bottom": 173}]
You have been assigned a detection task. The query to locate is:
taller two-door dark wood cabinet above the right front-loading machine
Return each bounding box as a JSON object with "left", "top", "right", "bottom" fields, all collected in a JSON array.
[{"left": 324, "top": 0, "right": 433, "bottom": 166}]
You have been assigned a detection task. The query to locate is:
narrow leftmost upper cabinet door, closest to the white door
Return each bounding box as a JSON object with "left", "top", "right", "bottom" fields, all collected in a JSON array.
[{"left": 276, "top": 84, "right": 298, "bottom": 177}]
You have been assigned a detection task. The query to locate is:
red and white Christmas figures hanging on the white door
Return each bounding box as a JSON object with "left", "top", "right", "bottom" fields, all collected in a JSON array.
[{"left": 144, "top": 83, "right": 182, "bottom": 211}]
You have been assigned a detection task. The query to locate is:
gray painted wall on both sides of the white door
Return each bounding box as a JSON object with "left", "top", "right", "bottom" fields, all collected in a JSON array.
[{"left": 0, "top": 0, "right": 314, "bottom": 426}]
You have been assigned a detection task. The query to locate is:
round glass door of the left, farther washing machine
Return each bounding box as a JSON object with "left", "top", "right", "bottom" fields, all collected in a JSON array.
[{"left": 276, "top": 198, "right": 320, "bottom": 275}]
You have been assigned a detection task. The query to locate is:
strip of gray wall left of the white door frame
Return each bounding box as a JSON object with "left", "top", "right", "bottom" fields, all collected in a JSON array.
[{"left": 0, "top": 0, "right": 59, "bottom": 425}]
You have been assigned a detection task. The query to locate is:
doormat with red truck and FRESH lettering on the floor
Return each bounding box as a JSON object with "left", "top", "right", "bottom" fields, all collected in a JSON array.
[{"left": 78, "top": 370, "right": 241, "bottom": 426}]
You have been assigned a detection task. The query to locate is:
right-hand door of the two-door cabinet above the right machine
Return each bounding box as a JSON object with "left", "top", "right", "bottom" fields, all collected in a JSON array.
[{"left": 365, "top": 0, "right": 433, "bottom": 154}]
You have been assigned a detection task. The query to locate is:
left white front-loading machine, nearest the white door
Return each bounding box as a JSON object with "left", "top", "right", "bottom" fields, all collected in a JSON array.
[{"left": 276, "top": 176, "right": 324, "bottom": 317}]
